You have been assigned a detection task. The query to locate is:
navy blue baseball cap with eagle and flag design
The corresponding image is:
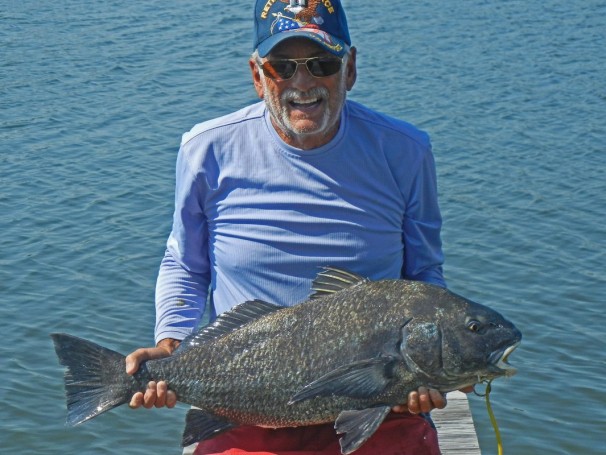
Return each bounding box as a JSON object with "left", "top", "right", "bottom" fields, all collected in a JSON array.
[{"left": 254, "top": 0, "right": 351, "bottom": 57}]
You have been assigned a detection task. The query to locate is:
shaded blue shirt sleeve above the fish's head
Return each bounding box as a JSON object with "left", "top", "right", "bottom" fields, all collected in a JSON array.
[{"left": 402, "top": 149, "right": 446, "bottom": 287}]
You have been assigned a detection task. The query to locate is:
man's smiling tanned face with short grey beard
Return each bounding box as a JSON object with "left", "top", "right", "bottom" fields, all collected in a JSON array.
[{"left": 251, "top": 38, "right": 355, "bottom": 149}]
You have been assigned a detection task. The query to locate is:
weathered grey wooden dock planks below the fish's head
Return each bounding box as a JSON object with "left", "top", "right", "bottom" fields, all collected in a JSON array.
[{"left": 431, "top": 392, "right": 481, "bottom": 455}]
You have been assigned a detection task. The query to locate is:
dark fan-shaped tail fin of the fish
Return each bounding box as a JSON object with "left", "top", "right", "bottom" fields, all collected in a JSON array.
[{"left": 51, "top": 333, "right": 141, "bottom": 426}]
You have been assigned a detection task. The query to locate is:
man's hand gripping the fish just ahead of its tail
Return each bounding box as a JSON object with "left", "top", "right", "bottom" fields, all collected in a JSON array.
[{"left": 126, "top": 338, "right": 180, "bottom": 409}]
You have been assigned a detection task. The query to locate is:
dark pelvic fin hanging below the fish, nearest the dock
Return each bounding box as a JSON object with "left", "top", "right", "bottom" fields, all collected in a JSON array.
[{"left": 335, "top": 406, "right": 391, "bottom": 454}]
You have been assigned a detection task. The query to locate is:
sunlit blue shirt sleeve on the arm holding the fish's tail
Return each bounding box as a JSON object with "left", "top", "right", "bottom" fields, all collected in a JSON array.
[{"left": 155, "top": 146, "right": 210, "bottom": 343}]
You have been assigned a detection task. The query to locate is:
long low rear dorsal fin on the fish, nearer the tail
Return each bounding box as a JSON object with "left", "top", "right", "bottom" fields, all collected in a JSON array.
[{"left": 175, "top": 300, "right": 284, "bottom": 353}]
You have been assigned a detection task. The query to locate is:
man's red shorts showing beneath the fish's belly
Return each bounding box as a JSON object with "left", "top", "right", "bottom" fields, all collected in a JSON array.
[{"left": 194, "top": 413, "right": 440, "bottom": 455}]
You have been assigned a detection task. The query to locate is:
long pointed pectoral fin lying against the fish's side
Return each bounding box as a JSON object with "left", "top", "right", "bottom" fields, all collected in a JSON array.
[{"left": 289, "top": 356, "right": 395, "bottom": 404}]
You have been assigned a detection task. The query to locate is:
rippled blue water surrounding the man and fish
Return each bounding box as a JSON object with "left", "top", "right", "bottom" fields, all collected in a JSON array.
[{"left": 0, "top": 0, "right": 606, "bottom": 455}]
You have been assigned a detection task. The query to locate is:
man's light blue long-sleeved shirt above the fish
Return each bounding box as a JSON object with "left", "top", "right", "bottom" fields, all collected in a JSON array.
[{"left": 156, "top": 101, "right": 445, "bottom": 341}]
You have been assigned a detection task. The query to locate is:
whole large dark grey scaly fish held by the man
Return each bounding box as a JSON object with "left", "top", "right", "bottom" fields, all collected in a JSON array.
[{"left": 52, "top": 268, "right": 521, "bottom": 453}]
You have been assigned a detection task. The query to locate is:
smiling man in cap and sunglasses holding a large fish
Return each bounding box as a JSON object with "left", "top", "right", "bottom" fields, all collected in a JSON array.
[{"left": 127, "top": 0, "right": 446, "bottom": 455}]
